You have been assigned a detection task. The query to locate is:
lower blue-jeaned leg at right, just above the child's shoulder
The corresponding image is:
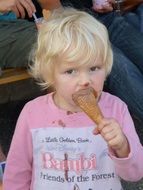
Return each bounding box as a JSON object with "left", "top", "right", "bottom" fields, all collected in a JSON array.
[{"left": 105, "top": 47, "right": 143, "bottom": 137}]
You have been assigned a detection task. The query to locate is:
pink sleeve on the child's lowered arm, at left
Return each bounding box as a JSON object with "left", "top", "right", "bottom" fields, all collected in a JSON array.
[{"left": 3, "top": 105, "right": 32, "bottom": 190}]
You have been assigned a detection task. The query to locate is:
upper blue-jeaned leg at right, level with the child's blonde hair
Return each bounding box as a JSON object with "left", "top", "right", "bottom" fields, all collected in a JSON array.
[{"left": 108, "top": 13, "right": 143, "bottom": 73}]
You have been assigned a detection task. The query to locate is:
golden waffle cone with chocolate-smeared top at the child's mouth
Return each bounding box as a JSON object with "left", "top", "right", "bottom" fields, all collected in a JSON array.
[{"left": 72, "top": 88, "right": 103, "bottom": 125}]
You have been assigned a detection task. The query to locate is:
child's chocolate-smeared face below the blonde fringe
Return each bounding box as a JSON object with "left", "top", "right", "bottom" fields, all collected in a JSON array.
[{"left": 54, "top": 59, "right": 106, "bottom": 112}]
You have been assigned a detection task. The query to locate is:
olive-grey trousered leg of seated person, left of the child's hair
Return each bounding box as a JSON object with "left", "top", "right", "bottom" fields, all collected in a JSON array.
[{"left": 0, "top": 19, "right": 37, "bottom": 68}]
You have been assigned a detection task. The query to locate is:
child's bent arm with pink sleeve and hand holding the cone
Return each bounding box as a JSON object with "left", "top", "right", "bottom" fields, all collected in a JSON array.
[{"left": 95, "top": 106, "right": 143, "bottom": 181}]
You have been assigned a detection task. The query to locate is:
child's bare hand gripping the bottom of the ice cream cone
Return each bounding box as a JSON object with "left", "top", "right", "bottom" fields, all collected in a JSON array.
[{"left": 93, "top": 118, "right": 130, "bottom": 158}]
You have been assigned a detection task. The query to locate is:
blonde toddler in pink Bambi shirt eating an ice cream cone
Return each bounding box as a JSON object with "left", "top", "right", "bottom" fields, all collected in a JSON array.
[{"left": 4, "top": 8, "right": 143, "bottom": 190}]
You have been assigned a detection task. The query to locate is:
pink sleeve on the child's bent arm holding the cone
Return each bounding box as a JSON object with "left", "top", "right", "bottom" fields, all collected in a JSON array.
[{"left": 111, "top": 106, "right": 143, "bottom": 181}]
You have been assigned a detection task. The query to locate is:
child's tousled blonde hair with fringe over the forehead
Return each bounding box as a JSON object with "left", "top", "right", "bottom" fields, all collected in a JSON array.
[{"left": 31, "top": 8, "right": 113, "bottom": 88}]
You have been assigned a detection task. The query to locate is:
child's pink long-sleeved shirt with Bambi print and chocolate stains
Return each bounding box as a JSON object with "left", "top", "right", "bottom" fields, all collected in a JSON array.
[{"left": 4, "top": 92, "right": 143, "bottom": 190}]
